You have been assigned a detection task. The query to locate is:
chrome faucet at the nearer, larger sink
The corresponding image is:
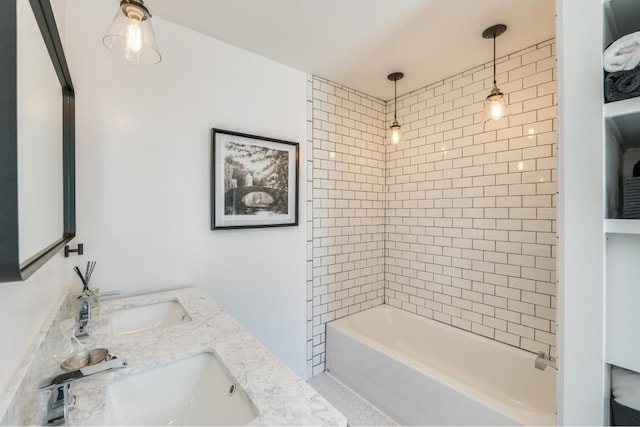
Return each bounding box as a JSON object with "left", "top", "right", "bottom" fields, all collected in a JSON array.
[{"left": 38, "top": 357, "right": 127, "bottom": 426}]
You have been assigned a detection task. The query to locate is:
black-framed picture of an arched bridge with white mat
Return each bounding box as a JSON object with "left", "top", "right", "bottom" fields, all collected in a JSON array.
[{"left": 211, "top": 129, "right": 299, "bottom": 230}]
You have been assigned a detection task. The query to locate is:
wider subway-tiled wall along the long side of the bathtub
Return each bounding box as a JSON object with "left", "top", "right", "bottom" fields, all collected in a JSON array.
[{"left": 385, "top": 40, "right": 557, "bottom": 355}]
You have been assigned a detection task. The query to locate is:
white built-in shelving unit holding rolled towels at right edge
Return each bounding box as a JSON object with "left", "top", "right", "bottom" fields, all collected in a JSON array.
[{"left": 603, "top": 0, "right": 640, "bottom": 378}]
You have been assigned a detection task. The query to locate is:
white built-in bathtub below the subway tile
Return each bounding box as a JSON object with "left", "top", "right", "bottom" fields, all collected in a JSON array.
[{"left": 326, "top": 305, "right": 556, "bottom": 425}]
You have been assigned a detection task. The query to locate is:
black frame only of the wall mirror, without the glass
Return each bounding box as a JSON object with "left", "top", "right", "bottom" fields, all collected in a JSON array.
[{"left": 0, "top": 0, "right": 76, "bottom": 282}]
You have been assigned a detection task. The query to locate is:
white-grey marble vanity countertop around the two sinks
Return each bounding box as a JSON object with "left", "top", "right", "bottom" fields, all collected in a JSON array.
[{"left": 61, "top": 288, "right": 346, "bottom": 426}]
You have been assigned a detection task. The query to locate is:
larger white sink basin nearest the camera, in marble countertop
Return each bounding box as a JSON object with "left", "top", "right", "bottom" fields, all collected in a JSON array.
[{"left": 106, "top": 353, "right": 257, "bottom": 425}]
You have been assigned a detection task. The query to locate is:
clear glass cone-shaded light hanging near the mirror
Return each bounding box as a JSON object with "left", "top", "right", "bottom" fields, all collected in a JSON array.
[{"left": 102, "top": 0, "right": 162, "bottom": 64}]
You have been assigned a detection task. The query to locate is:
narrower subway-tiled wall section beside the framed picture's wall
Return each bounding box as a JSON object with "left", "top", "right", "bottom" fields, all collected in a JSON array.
[{"left": 307, "top": 76, "right": 386, "bottom": 375}]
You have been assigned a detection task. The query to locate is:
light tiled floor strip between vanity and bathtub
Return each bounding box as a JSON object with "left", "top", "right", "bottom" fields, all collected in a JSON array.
[{"left": 307, "top": 372, "right": 398, "bottom": 426}]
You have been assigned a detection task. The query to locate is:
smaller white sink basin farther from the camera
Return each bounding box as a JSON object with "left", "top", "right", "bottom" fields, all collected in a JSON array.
[{"left": 110, "top": 300, "right": 191, "bottom": 335}]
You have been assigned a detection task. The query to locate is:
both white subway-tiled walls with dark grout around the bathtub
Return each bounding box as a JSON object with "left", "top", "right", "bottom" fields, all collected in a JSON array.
[{"left": 308, "top": 40, "right": 557, "bottom": 375}]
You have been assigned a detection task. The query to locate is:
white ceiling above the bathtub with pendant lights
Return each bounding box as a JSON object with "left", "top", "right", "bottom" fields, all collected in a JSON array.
[{"left": 145, "top": 0, "right": 555, "bottom": 100}]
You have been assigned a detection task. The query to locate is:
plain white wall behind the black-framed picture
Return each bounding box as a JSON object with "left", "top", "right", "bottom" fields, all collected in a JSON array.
[{"left": 65, "top": 0, "right": 306, "bottom": 374}]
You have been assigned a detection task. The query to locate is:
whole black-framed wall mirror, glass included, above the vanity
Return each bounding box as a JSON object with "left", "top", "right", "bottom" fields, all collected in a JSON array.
[{"left": 0, "top": 0, "right": 75, "bottom": 282}]
